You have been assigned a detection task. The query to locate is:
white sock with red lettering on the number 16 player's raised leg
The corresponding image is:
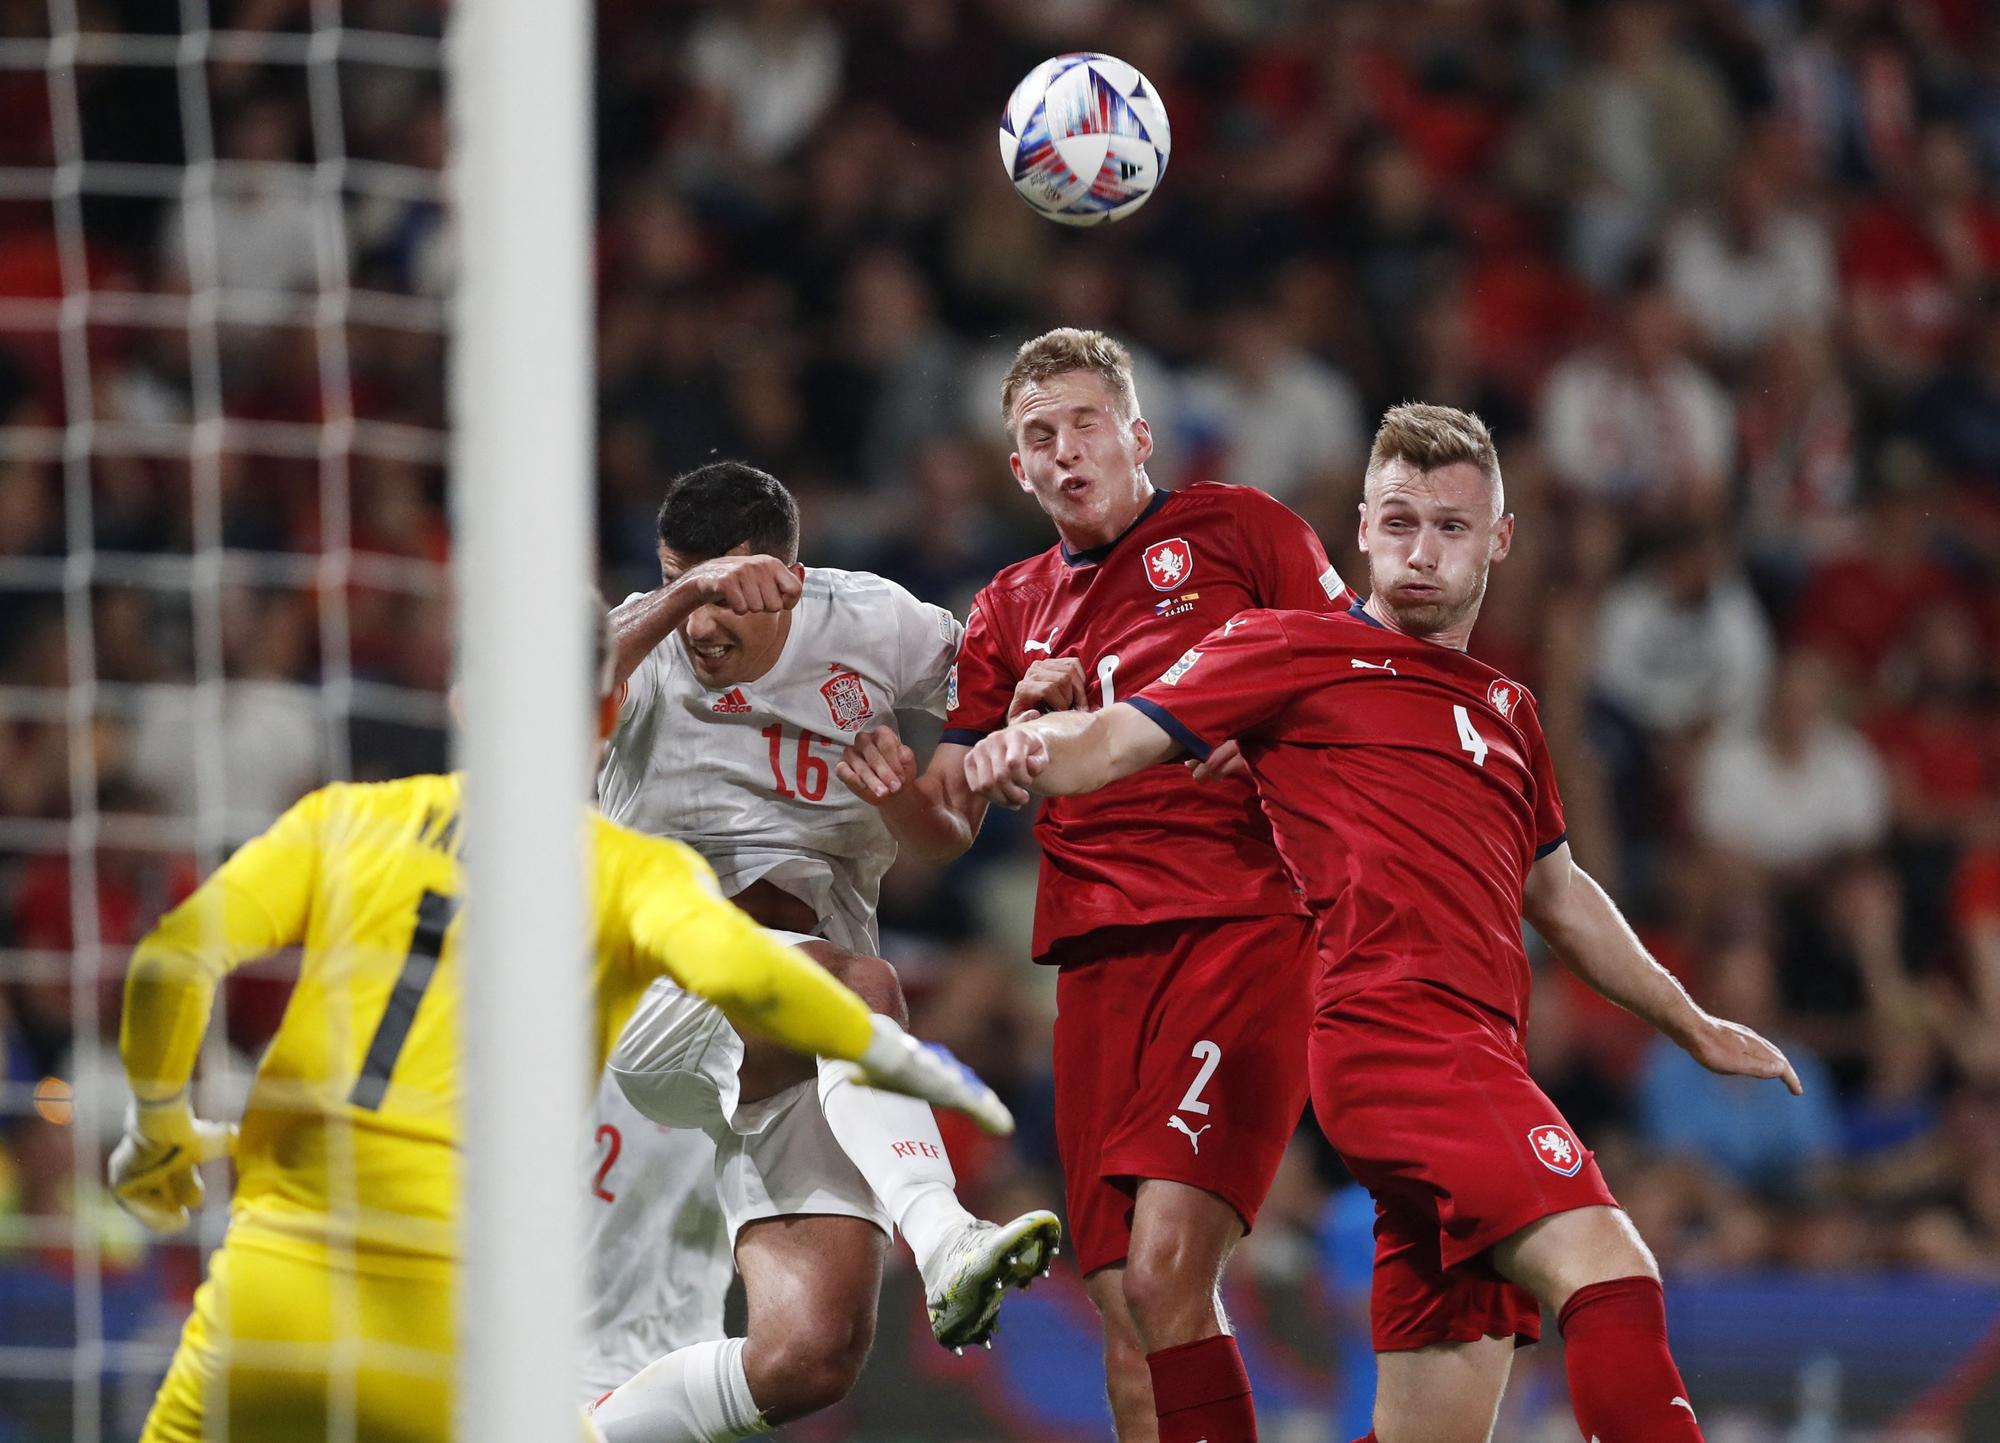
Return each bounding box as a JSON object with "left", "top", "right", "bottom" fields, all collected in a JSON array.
[{"left": 820, "top": 1057, "right": 974, "bottom": 1281}]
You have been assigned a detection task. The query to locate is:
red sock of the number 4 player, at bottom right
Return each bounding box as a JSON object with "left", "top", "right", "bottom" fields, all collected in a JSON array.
[{"left": 1556, "top": 1277, "right": 1702, "bottom": 1443}]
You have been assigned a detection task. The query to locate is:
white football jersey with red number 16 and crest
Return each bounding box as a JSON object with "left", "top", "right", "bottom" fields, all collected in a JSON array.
[{"left": 598, "top": 566, "right": 964, "bottom": 953}]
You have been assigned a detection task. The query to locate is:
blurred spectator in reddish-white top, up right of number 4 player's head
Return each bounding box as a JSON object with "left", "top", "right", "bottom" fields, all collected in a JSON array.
[{"left": 1542, "top": 276, "right": 1732, "bottom": 516}]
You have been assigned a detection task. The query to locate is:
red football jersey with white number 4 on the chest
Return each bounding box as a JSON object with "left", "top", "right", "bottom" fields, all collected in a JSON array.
[{"left": 1130, "top": 606, "right": 1564, "bottom": 1025}]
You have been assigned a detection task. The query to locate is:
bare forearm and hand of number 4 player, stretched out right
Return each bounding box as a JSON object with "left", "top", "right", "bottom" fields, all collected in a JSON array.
[{"left": 1522, "top": 841, "right": 1802, "bottom": 1095}]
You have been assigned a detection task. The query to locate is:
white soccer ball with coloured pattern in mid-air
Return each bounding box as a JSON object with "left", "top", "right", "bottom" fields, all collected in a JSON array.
[{"left": 1000, "top": 52, "right": 1172, "bottom": 226}]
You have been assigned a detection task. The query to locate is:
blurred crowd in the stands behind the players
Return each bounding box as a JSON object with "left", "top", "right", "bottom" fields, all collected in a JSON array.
[{"left": 0, "top": 0, "right": 2000, "bottom": 1359}]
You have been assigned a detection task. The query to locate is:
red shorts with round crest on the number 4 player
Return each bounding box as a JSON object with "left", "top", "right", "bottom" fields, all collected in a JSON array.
[{"left": 1310, "top": 981, "right": 1618, "bottom": 1353}]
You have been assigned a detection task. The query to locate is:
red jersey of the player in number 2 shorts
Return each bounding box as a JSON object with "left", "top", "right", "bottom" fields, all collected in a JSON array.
[{"left": 944, "top": 482, "right": 1348, "bottom": 959}]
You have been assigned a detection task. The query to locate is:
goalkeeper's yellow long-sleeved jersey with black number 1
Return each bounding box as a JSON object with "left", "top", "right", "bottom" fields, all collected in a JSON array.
[{"left": 120, "top": 775, "right": 870, "bottom": 1261}]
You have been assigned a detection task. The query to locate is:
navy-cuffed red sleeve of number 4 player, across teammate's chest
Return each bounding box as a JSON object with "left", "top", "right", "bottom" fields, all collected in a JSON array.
[{"left": 1128, "top": 612, "right": 1300, "bottom": 759}]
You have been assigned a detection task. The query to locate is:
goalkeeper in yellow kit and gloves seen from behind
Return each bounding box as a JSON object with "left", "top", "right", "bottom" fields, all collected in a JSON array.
[{"left": 110, "top": 606, "right": 1012, "bottom": 1443}]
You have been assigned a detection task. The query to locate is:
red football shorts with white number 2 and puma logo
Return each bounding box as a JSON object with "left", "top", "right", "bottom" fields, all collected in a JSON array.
[{"left": 1056, "top": 915, "right": 1318, "bottom": 1277}]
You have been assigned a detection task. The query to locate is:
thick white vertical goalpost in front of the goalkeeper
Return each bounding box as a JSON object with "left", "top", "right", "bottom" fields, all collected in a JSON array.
[{"left": 450, "top": 0, "right": 594, "bottom": 1443}]
